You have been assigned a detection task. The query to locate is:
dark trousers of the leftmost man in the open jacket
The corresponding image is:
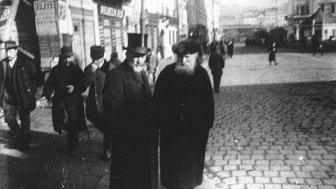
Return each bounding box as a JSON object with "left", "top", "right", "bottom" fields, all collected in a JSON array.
[{"left": 3, "top": 102, "right": 30, "bottom": 142}]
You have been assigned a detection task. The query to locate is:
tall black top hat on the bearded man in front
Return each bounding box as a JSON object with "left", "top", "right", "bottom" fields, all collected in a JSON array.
[{"left": 124, "top": 33, "right": 148, "bottom": 55}]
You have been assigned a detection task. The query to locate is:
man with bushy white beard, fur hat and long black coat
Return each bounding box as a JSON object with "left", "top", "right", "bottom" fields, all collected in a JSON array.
[{"left": 153, "top": 39, "right": 214, "bottom": 189}]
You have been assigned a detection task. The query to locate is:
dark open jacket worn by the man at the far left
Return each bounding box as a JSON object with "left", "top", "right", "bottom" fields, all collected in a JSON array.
[{"left": 0, "top": 54, "right": 37, "bottom": 110}]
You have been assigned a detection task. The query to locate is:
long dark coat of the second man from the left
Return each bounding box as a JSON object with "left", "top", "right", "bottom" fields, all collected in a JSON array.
[{"left": 42, "top": 63, "right": 87, "bottom": 133}]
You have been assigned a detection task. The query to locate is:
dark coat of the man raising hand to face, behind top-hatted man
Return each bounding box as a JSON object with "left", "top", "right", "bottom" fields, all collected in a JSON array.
[{"left": 84, "top": 61, "right": 114, "bottom": 132}]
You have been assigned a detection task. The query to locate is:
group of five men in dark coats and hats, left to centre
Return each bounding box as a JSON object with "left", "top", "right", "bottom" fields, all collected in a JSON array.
[{"left": 0, "top": 34, "right": 214, "bottom": 189}]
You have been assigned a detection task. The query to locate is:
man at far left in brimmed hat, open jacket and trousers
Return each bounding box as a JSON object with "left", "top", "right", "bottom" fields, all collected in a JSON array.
[{"left": 0, "top": 41, "right": 37, "bottom": 150}]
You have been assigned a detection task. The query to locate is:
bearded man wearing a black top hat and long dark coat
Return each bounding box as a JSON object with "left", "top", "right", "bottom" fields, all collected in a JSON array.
[{"left": 103, "top": 33, "right": 158, "bottom": 189}]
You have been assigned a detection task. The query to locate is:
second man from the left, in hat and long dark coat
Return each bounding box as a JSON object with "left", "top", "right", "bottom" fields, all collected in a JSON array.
[{"left": 39, "top": 46, "right": 87, "bottom": 156}]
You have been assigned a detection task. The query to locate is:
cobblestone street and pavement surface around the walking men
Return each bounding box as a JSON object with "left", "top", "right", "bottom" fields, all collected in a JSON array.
[{"left": 0, "top": 44, "right": 336, "bottom": 189}]
